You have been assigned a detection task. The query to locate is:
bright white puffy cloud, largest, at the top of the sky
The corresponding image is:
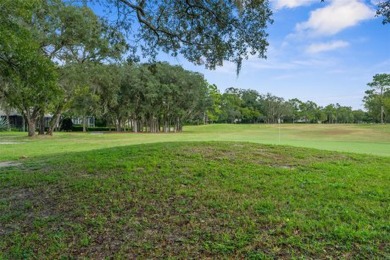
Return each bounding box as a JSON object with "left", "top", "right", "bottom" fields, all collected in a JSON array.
[{"left": 296, "top": 0, "right": 375, "bottom": 36}]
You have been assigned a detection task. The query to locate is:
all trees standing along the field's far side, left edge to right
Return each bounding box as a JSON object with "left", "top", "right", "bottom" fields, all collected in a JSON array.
[{"left": 0, "top": 0, "right": 390, "bottom": 136}]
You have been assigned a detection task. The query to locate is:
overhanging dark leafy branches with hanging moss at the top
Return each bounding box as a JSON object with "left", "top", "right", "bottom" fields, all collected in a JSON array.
[{"left": 95, "top": 0, "right": 272, "bottom": 73}]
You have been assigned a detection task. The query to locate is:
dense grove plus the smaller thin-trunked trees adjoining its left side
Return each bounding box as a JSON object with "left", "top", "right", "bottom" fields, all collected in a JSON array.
[{"left": 62, "top": 63, "right": 208, "bottom": 132}]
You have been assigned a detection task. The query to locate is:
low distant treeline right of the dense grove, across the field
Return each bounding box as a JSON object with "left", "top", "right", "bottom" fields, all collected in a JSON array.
[{"left": 207, "top": 86, "right": 378, "bottom": 124}]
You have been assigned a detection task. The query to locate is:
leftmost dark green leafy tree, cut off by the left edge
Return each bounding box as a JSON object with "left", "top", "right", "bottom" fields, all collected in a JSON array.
[{"left": 0, "top": 0, "right": 59, "bottom": 136}]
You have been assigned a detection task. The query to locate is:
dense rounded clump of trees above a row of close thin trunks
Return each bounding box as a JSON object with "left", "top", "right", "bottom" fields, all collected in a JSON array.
[{"left": 93, "top": 63, "right": 207, "bottom": 132}]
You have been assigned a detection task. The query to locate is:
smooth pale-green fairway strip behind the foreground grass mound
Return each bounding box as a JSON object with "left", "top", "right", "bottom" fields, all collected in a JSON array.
[{"left": 0, "top": 124, "right": 390, "bottom": 161}]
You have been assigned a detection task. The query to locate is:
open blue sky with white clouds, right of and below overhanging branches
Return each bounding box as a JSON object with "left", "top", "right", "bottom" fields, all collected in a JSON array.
[{"left": 159, "top": 0, "right": 390, "bottom": 109}]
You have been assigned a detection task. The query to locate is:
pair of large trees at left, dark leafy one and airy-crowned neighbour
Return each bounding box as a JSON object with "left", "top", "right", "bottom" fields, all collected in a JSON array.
[{"left": 0, "top": 0, "right": 127, "bottom": 135}]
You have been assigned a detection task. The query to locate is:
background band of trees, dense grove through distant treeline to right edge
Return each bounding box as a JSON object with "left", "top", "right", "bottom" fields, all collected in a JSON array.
[{"left": 0, "top": 56, "right": 390, "bottom": 134}]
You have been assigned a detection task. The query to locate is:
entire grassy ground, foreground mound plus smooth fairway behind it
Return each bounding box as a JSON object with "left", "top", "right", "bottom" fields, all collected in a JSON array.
[{"left": 0, "top": 125, "right": 390, "bottom": 259}]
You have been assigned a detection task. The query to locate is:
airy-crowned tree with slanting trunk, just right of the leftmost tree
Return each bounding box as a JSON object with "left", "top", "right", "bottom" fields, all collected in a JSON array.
[{"left": 34, "top": 0, "right": 128, "bottom": 134}]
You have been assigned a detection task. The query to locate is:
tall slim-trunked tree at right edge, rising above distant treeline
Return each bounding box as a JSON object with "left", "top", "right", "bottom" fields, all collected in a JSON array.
[{"left": 365, "top": 73, "right": 390, "bottom": 124}]
